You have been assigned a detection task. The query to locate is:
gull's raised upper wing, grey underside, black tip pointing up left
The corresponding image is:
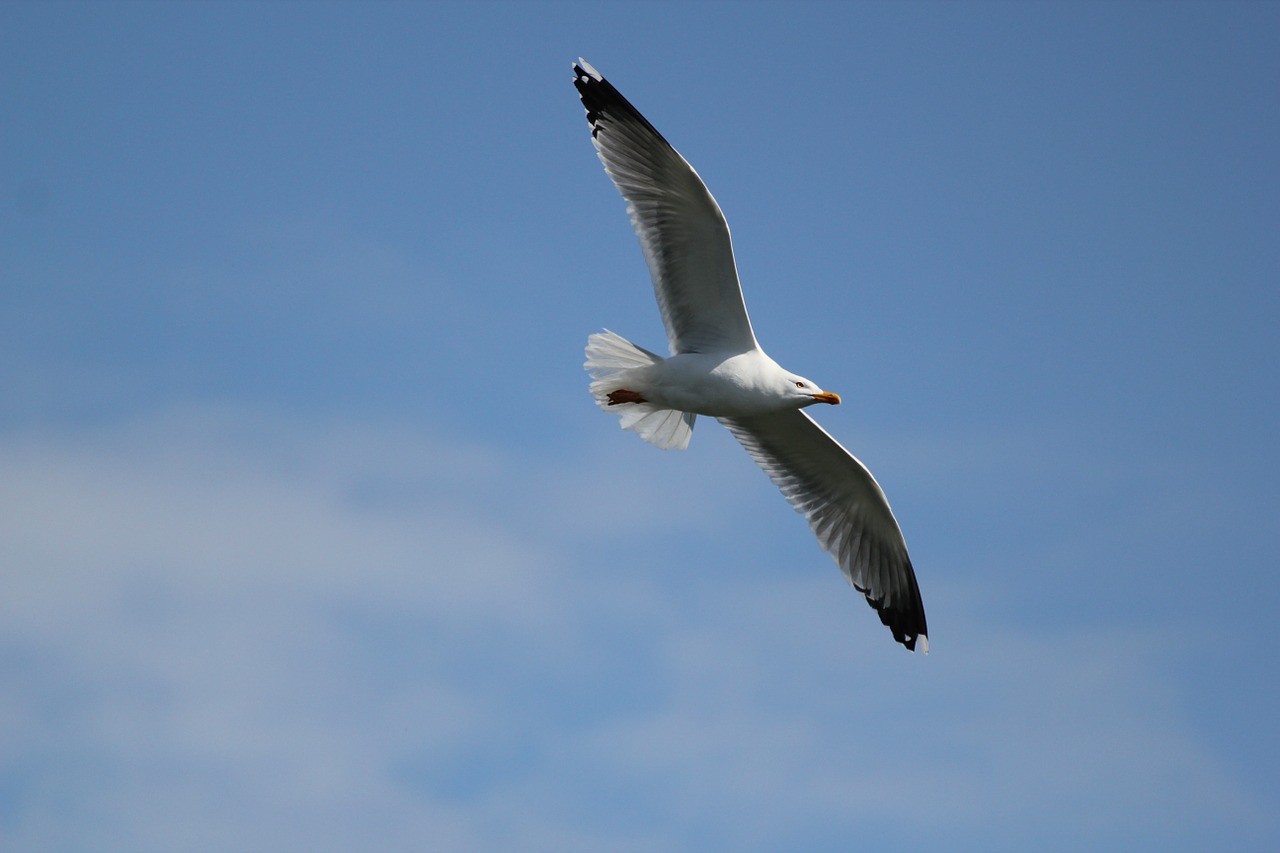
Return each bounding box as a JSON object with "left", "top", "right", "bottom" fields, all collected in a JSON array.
[{"left": 573, "top": 59, "right": 756, "bottom": 355}]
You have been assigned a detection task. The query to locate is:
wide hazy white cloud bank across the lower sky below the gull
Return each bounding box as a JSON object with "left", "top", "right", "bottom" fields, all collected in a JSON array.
[{"left": 0, "top": 409, "right": 1265, "bottom": 850}]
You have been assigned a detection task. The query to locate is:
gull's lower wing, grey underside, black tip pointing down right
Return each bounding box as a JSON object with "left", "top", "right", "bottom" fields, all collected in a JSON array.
[{"left": 719, "top": 409, "right": 929, "bottom": 652}]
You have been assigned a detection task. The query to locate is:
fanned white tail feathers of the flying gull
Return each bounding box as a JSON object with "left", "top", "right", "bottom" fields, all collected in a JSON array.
[{"left": 582, "top": 329, "right": 698, "bottom": 450}]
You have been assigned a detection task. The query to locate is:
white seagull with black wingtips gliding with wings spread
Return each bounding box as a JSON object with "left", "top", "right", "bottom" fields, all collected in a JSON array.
[{"left": 573, "top": 59, "right": 929, "bottom": 653}]
